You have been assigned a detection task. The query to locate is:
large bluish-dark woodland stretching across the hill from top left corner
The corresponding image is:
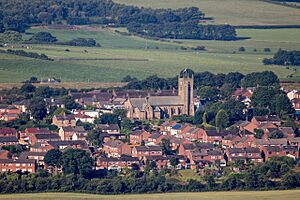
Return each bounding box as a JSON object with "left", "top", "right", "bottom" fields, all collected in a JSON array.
[{"left": 0, "top": 0, "right": 235, "bottom": 40}]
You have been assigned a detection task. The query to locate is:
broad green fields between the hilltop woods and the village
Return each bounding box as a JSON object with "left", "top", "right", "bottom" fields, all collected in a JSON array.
[{"left": 0, "top": 27, "right": 300, "bottom": 83}]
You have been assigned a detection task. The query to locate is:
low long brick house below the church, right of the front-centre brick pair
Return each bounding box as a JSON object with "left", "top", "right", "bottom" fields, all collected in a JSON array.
[{"left": 132, "top": 146, "right": 162, "bottom": 157}]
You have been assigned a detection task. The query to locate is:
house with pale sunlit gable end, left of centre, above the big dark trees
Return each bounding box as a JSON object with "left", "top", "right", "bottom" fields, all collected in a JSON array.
[{"left": 58, "top": 126, "right": 87, "bottom": 140}]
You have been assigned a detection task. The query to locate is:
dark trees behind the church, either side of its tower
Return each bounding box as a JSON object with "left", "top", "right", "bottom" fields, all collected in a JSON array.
[{"left": 123, "top": 71, "right": 279, "bottom": 91}]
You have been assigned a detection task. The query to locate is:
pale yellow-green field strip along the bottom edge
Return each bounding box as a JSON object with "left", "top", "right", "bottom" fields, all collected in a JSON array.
[{"left": 0, "top": 190, "right": 300, "bottom": 200}]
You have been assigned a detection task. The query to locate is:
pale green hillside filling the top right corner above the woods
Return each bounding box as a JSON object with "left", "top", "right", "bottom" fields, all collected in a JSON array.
[{"left": 114, "top": 0, "right": 300, "bottom": 25}]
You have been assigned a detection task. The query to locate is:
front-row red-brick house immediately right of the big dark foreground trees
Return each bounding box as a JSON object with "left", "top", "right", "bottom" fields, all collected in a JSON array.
[{"left": 96, "top": 156, "right": 141, "bottom": 171}]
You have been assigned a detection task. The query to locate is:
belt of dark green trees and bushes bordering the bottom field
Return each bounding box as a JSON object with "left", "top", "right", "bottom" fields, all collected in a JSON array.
[{"left": 0, "top": 155, "right": 300, "bottom": 194}]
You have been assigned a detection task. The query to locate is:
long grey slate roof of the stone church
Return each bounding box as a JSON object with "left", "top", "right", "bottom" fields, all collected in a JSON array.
[{"left": 130, "top": 96, "right": 183, "bottom": 111}]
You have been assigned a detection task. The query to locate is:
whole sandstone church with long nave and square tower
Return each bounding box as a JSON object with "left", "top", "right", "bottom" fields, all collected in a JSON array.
[{"left": 125, "top": 69, "right": 195, "bottom": 120}]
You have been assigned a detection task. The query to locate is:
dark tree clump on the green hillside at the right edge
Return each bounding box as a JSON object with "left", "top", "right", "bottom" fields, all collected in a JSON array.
[{"left": 263, "top": 49, "right": 300, "bottom": 66}]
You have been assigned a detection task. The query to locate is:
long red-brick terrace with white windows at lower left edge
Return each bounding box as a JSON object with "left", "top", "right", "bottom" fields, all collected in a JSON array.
[{"left": 0, "top": 159, "right": 36, "bottom": 173}]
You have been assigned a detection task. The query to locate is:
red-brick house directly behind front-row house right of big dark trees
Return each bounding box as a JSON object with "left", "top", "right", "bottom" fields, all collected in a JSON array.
[{"left": 102, "top": 140, "right": 131, "bottom": 158}]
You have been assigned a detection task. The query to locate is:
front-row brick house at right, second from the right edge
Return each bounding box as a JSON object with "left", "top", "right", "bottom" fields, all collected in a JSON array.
[{"left": 225, "top": 147, "right": 263, "bottom": 163}]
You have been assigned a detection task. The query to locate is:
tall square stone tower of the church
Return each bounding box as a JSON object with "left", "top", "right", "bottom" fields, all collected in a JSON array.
[{"left": 178, "top": 69, "right": 195, "bottom": 116}]
